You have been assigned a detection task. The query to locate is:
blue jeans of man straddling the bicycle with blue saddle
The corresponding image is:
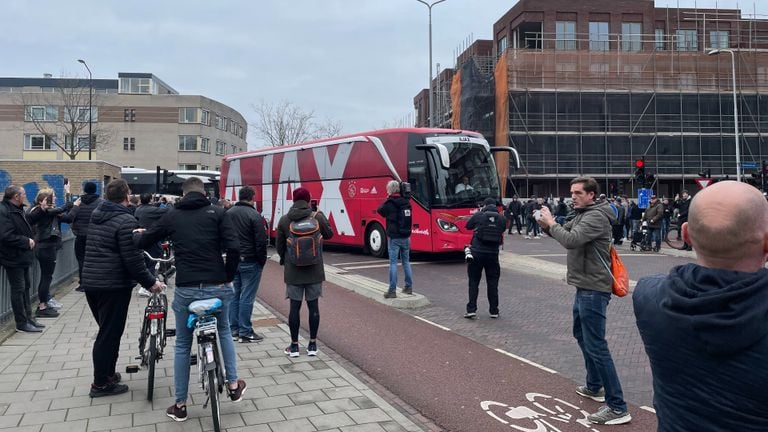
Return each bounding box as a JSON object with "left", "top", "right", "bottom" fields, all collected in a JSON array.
[{"left": 172, "top": 285, "right": 237, "bottom": 403}]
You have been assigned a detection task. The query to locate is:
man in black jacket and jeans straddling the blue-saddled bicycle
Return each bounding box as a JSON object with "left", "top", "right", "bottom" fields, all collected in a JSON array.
[{"left": 135, "top": 177, "right": 246, "bottom": 421}]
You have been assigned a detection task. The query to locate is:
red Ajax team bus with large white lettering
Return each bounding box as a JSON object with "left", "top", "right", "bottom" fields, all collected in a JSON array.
[{"left": 220, "top": 128, "right": 520, "bottom": 257}]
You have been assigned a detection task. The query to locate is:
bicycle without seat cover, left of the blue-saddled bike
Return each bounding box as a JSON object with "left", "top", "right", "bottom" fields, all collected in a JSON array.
[{"left": 125, "top": 243, "right": 176, "bottom": 401}]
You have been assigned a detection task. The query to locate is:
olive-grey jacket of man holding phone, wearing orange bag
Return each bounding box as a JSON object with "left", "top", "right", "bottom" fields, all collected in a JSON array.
[{"left": 549, "top": 201, "right": 616, "bottom": 293}]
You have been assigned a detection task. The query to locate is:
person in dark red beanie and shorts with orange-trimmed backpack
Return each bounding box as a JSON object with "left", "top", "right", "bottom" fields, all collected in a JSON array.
[{"left": 275, "top": 187, "right": 333, "bottom": 357}]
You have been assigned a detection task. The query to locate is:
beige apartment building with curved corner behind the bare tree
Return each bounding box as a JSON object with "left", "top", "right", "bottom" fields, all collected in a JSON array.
[{"left": 0, "top": 72, "right": 247, "bottom": 171}]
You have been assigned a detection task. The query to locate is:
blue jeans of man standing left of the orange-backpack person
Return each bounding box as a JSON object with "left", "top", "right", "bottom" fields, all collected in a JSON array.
[{"left": 229, "top": 262, "right": 264, "bottom": 336}]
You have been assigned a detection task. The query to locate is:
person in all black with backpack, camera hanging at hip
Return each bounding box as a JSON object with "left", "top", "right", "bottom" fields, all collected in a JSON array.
[{"left": 464, "top": 197, "right": 506, "bottom": 319}]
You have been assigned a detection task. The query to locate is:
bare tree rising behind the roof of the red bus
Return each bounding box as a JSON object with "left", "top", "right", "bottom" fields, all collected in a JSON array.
[{"left": 251, "top": 100, "right": 342, "bottom": 147}]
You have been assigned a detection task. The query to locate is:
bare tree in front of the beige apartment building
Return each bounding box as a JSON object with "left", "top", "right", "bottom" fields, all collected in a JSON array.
[{"left": 20, "top": 77, "right": 111, "bottom": 159}]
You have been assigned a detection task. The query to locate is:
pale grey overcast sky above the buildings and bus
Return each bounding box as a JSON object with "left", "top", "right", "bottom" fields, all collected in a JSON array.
[{"left": 0, "top": 0, "right": 768, "bottom": 147}]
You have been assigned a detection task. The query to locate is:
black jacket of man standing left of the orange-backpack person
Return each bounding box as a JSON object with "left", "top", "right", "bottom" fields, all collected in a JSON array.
[{"left": 227, "top": 202, "right": 267, "bottom": 266}]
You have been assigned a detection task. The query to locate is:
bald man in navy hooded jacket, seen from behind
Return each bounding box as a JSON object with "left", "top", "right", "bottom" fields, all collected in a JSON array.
[{"left": 632, "top": 181, "right": 768, "bottom": 432}]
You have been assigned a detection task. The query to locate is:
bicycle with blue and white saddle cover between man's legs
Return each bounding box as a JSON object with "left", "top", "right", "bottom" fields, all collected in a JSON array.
[{"left": 187, "top": 298, "right": 227, "bottom": 432}]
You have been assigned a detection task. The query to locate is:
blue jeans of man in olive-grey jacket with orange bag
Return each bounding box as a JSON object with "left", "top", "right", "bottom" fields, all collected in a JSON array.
[{"left": 573, "top": 288, "right": 627, "bottom": 411}]
